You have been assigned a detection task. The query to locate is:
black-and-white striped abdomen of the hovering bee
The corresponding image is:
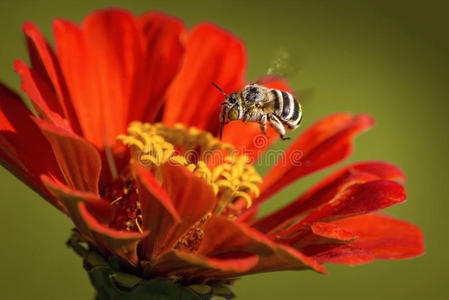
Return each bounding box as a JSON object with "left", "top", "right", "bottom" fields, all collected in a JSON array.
[{"left": 269, "top": 89, "right": 302, "bottom": 129}]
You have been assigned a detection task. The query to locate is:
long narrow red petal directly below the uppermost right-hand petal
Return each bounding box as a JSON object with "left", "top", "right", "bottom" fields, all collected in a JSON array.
[{"left": 253, "top": 161, "right": 405, "bottom": 234}]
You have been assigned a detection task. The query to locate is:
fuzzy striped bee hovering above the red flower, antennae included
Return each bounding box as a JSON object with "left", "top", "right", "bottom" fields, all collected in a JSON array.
[{"left": 211, "top": 82, "right": 302, "bottom": 140}]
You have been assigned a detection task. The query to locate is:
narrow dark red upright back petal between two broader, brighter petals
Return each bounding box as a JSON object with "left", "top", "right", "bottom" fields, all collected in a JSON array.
[{"left": 129, "top": 11, "right": 185, "bottom": 123}]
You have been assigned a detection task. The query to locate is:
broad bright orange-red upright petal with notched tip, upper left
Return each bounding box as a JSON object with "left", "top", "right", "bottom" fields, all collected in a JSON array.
[{"left": 53, "top": 9, "right": 143, "bottom": 149}]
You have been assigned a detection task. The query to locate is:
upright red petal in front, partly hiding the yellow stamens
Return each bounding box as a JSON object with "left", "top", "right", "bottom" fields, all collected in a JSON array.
[{"left": 136, "top": 163, "right": 216, "bottom": 258}]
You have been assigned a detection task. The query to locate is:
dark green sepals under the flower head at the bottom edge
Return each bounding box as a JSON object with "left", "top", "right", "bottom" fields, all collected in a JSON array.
[{"left": 67, "top": 230, "right": 235, "bottom": 300}]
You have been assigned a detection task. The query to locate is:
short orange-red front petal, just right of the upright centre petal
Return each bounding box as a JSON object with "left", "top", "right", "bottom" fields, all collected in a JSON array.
[{"left": 198, "top": 216, "right": 275, "bottom": 256}]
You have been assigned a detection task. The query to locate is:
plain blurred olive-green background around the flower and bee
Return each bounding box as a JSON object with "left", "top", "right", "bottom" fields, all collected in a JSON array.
[{"left": 0, "top": 0, "right": 449, "bottom": 300}]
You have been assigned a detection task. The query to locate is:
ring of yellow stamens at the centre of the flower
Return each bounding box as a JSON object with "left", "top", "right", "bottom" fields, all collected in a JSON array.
[{"left": 117, "top": 122, "right": 262, "bottom": 216}]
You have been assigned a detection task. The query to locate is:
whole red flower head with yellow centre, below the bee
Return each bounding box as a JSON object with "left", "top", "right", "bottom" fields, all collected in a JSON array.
[{"left": 0, "top": 9, "right": 424, "bottom": 280}]
